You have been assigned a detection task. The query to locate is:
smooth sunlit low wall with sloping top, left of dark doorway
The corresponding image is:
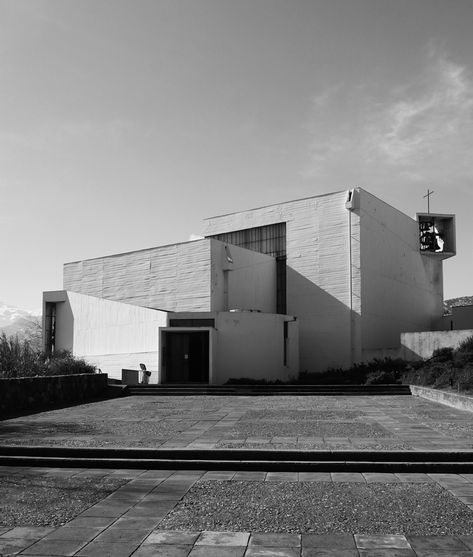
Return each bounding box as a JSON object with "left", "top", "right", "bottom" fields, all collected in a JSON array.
[{"left": 43, "top": 291, "right": 167, "bottom": 382}]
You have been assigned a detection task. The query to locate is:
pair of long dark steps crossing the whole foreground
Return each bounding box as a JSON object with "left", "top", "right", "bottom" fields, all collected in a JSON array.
[{"left": 0, "top": 446, "right": 473, "bottom": 474}]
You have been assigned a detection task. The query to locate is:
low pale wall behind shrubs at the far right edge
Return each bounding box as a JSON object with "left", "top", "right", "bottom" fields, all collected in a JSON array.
[{"left": 400, "top": 329, "right": 473, "bottom": 360}]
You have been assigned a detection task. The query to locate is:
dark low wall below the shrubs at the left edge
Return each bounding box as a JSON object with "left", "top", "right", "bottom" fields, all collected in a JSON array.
[{"left": 0, "top": 373, "right": 107, "bottom": 415}]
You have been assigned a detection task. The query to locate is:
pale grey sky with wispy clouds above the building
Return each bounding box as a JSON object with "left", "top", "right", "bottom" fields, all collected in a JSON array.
[{"left": 0, "top": 0, "right": 473, "bottom": 309}]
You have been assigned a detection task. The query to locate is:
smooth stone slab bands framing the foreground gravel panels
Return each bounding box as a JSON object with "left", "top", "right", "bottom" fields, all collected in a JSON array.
[{"left": 0, "top": 468, "right": 473, "bottom": 557}]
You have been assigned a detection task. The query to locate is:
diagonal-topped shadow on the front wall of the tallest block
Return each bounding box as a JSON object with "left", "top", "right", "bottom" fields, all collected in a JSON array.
[{"left": 286, "top": 267, "right": 361, "bottom": 372}]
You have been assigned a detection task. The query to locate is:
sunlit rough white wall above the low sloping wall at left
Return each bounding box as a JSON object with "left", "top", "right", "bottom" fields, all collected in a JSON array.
[{"left": 64, "top": 240, "right": 211, "bottom": 311}]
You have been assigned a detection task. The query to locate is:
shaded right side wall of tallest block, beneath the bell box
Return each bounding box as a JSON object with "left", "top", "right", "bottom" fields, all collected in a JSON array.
[{"left": 359, "top": 190, "right": 443, "bottom": 359}]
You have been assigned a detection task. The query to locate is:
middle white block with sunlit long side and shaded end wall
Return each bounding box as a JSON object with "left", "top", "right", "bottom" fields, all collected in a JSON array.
[{"left": 64, "top": 240, "right": 276, "bottom": 318}]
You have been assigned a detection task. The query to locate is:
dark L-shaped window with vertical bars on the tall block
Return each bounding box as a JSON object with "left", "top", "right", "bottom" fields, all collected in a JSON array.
[{"left": 208, "top": 222, "right": 286, "bottom": 314}]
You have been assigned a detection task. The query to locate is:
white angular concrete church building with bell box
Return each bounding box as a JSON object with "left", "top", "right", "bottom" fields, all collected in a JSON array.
[{"left": 44, "top": 188, "right": 455, "bottom": 384}]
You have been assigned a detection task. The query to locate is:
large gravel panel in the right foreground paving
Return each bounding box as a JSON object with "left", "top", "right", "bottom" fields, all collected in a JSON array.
[{"left": 160, "top": 481, "right": 473, "bottom": 535}]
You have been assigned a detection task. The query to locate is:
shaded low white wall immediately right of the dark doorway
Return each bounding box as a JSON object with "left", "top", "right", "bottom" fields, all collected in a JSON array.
[{"left": 214, "top": 312, "right": 298, "bottom": 384}]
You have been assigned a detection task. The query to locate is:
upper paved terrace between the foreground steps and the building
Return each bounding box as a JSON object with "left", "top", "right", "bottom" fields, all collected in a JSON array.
[{"left": 0, "top": 396, "right": 473, "bottom": 450}]
